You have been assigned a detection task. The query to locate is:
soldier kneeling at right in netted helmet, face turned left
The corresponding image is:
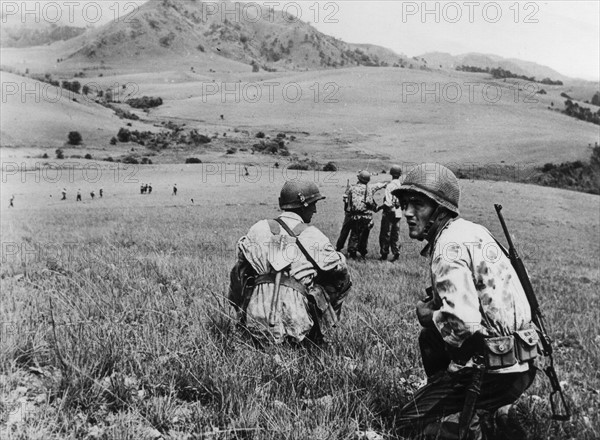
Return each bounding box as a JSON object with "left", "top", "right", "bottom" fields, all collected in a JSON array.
[{"left": 393, "top": 164, "right": 538, "bottom": 439}]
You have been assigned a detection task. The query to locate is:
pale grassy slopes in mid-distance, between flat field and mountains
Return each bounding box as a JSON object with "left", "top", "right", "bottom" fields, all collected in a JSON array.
[{"left": 2, "top": 67, "right": 599, "bottom": 169}]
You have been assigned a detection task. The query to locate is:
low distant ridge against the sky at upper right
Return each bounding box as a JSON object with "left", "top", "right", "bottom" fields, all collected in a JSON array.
[{"left": 418, "top": 52, "right": 571, "bottom": 81}]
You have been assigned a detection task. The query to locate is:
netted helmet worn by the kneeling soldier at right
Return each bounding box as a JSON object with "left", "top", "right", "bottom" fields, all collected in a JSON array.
[{"left": 392, "top": 163, "right": 460, "bottom": 215}]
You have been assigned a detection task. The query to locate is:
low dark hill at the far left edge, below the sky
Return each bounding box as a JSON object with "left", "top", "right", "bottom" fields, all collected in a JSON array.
[{"left": 0, "top": 24, "right": 86, "bottom": 48}]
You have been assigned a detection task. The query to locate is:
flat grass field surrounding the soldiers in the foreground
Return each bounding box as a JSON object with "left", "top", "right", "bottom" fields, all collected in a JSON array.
[{"left": 0, "top": 164, "right": 600, "bottom": 440}]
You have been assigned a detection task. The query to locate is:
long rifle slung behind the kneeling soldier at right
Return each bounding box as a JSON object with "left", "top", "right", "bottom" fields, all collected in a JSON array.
[{"left": 494, "top": 204, "right": 571, "bottom": 420}]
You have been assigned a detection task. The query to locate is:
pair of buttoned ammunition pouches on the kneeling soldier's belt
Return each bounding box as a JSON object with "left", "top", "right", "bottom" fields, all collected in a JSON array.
[{"left": 484, "top": 328, "right": 539, "bottom": 370}]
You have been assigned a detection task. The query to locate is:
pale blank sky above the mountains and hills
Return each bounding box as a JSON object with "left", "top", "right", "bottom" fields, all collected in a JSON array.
[{"left": 1, "top": 0, "right": 600, "bottom": 81}]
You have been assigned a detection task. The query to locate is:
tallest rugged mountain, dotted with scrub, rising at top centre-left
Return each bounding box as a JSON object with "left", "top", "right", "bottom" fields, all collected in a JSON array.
[{"left": 54, "top": 0, "right": 410, "bottom": 70}]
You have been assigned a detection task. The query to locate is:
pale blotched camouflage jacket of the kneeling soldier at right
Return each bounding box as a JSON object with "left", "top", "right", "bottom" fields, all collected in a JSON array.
[{"left": 422, "top": 218, "right": 531, "bottom": 373}]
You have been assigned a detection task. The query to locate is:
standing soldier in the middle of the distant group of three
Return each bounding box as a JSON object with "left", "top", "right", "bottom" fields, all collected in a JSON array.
[{"left": 346, "top": 171, "right": 386, "bottom": 259}]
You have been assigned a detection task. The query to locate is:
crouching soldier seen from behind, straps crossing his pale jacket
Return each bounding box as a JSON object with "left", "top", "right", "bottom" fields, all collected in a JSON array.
[{"left": 229, "top": 181, "right": 351, "bottom": 343}]
